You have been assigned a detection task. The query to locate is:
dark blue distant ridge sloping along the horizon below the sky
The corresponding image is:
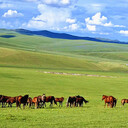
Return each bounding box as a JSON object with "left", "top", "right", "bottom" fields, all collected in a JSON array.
[{"left": 14, "top": 29, "right": 128, "bottom": 44}]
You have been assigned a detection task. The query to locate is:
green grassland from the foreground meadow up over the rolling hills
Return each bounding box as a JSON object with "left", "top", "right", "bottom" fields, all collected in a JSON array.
[{"left": 0, "top": 30, "right": 128, "bottom": 128}]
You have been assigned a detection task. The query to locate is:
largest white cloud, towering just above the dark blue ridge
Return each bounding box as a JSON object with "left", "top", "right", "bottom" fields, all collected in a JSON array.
[{"left": 24, "top": 4, "right": 71, "bottom": 29}]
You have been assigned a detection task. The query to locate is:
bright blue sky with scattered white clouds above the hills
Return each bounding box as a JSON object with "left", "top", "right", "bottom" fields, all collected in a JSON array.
[{"left": 0, "top": 0, "right": 128, "bottom": 42}]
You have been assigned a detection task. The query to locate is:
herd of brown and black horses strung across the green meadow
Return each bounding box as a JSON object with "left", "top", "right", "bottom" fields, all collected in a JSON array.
[{"left": 0, "top": 94, "right": 128, "bottom": 109}]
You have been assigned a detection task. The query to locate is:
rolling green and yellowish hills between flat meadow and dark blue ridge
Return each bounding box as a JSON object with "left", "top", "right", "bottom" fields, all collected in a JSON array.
[{"left": 0, "top": 29, "right": 128, "bottom": 72}]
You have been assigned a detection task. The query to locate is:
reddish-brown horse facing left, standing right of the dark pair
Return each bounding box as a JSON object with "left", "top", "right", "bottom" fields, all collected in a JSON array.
[{"left": 102, "top": 95, "right": 117, "bottom": 108}]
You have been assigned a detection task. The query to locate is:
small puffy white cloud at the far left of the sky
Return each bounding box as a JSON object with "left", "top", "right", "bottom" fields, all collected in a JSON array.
[{"left": 3, "top": 10, "right": 23, "bottom": 17}]
